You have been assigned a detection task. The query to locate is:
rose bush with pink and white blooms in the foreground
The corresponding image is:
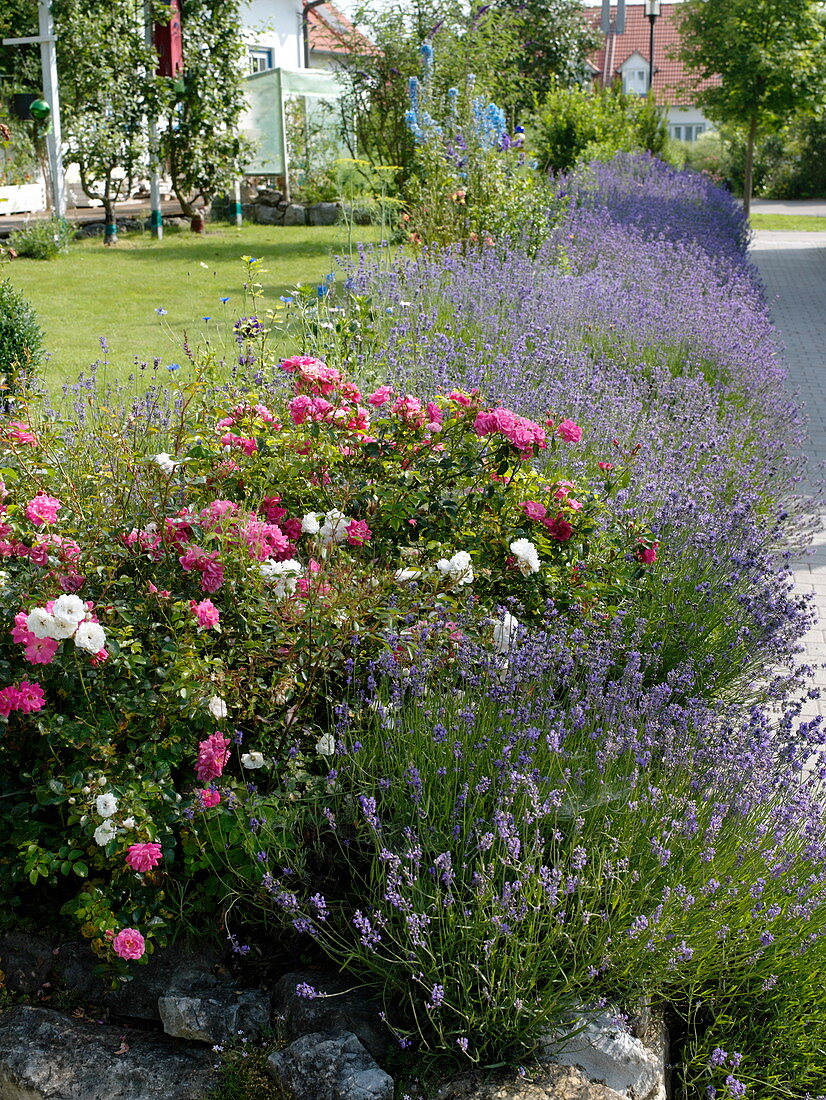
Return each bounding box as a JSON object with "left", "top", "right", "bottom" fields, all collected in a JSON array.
[{"left": 0, "top": 356, "right": 656, "bottom": 958}]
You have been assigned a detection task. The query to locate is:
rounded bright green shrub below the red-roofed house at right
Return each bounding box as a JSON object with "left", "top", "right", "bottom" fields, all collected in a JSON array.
[{"left": 529, "top": 87, "right": 668, "bottom": 173}]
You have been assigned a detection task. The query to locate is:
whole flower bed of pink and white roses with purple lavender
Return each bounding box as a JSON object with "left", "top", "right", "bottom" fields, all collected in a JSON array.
[{"left": 0, "top": 156, "right": 826, "bottom": 1100}]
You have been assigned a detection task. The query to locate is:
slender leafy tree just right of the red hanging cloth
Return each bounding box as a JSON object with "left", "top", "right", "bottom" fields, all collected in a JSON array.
[{"left": 161, "top": 0, "right": 249, "bottom": 224}]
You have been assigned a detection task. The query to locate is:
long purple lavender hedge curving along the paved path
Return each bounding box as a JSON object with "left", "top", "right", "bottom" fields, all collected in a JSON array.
[{"left": 248, "top": 156, "right": 826, "bottom": 1098}]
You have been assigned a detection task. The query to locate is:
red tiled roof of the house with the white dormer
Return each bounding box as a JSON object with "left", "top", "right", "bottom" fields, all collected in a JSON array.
[{"left": 587, "top": 3, "right": 719, "bottom": 107}]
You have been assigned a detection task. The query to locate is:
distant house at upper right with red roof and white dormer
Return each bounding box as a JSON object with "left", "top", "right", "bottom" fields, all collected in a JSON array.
[{"left": 588, "top": 3, "right": 716, "bottom": 141}]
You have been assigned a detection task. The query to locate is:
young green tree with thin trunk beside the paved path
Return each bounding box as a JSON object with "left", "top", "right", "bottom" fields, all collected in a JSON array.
[{"left": 680, "top": 0, "right": 826, "bottom": 213}]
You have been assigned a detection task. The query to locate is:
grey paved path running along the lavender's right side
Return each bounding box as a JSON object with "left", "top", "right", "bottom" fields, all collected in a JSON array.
[{"left": 751, "top": 230, "right": 826, "bottom": 715}]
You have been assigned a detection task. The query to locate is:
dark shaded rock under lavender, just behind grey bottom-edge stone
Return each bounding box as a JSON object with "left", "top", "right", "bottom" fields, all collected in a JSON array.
[{"left": 273, "top": 970, "right": 392, "bottom": 1062}]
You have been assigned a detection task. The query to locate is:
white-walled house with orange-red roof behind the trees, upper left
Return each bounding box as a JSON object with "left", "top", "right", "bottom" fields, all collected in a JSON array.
[{"left": 241, "top": 0, "right": 370, "bottom": 73}]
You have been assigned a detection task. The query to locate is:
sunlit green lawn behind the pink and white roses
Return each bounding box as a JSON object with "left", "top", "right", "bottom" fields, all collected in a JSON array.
[{"left": 0, "top": 223, "right": 389, "bottom": 386}]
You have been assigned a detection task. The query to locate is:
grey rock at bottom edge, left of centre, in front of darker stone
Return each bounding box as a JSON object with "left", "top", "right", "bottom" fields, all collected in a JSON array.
[{"left": 267, "top": 1032, "right": 394, "bottom": 1100}]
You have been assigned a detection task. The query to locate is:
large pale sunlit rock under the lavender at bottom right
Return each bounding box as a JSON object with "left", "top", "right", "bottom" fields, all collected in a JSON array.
[{"left": 544, "top": 1012, "right": 665, "bottom": 1100}]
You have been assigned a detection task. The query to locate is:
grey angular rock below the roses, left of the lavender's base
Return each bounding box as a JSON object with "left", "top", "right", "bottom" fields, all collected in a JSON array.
[{"left": 157, "top": 988, "right": 271, "bottom": 1043}]
